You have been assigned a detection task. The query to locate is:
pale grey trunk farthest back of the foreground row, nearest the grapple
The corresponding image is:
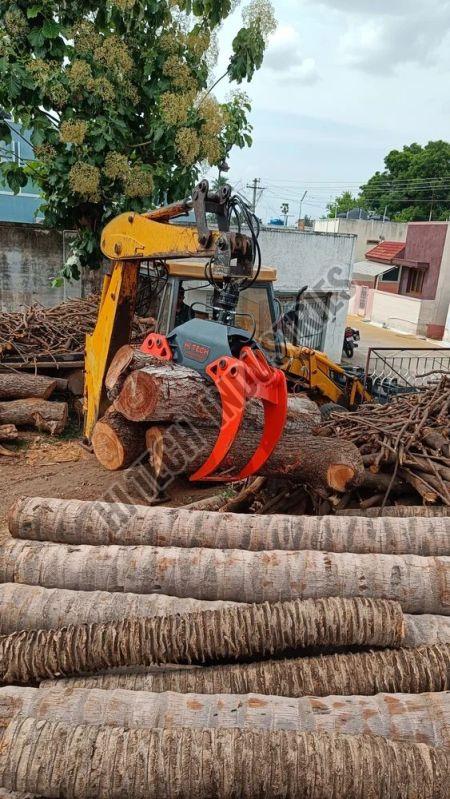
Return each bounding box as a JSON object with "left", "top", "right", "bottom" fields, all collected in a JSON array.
[{"left": 8, "top": 497, "right": 450, "bottom": 556}]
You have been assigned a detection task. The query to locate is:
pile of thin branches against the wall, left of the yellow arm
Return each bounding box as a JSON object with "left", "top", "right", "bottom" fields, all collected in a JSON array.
[{"left": 0, "top": 294, "right": 148, "bottom": 363}]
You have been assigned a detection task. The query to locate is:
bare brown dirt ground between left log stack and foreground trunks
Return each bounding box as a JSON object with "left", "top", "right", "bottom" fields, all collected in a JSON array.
[{"left": 0, "top": 432, "right": 217, "bottom": 538}]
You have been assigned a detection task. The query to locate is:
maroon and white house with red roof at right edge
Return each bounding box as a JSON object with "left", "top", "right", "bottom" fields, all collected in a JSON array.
[{"left": 350, "top": 222, "right": 450, "bottom": 340}]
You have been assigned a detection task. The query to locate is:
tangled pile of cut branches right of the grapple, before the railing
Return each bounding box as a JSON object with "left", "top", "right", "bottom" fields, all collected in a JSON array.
[{"left": 320, "top": 377, "right": 450, "bottom": 508}]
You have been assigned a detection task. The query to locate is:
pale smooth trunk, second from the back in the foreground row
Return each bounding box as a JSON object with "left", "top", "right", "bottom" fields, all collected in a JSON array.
[{"left": 0, "top": 539, "right": 450, "bottom": 616}]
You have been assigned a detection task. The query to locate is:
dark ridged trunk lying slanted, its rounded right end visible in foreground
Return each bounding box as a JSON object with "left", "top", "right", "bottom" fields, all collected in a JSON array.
[{"left": 0, "top": 599, "right": 403, "bottom": 684}]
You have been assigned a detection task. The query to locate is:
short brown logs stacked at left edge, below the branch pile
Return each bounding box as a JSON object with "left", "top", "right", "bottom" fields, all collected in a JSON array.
[{"left": 0, "top": 371, "right": 68, "bottom": 455}]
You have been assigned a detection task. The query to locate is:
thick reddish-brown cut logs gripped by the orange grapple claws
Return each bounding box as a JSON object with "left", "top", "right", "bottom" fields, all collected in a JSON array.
[{"left": 92, "top": 346, "right": 364, "bottom": 495}]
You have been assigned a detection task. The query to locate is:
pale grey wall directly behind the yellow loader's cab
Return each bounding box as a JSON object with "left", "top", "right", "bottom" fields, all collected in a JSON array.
[{"left": 259, "top": 228, "right": 355, "bottom": 362}]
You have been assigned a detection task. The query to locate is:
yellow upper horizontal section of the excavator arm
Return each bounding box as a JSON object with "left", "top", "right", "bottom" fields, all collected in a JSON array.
[{"left": 101, "top": 212, "right": 221, "bottom": 261}]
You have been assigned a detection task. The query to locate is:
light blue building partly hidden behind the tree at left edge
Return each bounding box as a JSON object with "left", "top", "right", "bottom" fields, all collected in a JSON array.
[{"left": 0, "top": 119, "right": 42, "bottom": 223}]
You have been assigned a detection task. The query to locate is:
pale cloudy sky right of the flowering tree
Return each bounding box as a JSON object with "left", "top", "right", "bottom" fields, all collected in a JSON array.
[{"left": 213, "top": 0, "right": 450, "bottom": 224}]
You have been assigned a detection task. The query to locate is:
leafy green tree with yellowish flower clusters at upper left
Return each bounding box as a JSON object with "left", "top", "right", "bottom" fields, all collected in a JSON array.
[{"left": 0, "top": 0, "right": 275, "bottom": 278}]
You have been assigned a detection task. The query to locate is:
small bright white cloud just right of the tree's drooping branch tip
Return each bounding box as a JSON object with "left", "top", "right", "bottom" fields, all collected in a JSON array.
[{"left": 264, "top": 25, "right": 319, "bottom": 85}]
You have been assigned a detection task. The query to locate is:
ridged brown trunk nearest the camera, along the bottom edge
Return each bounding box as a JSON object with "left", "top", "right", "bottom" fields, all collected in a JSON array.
[{"left": 0, "top": 714, "right": 448, "bottom": 799}]
